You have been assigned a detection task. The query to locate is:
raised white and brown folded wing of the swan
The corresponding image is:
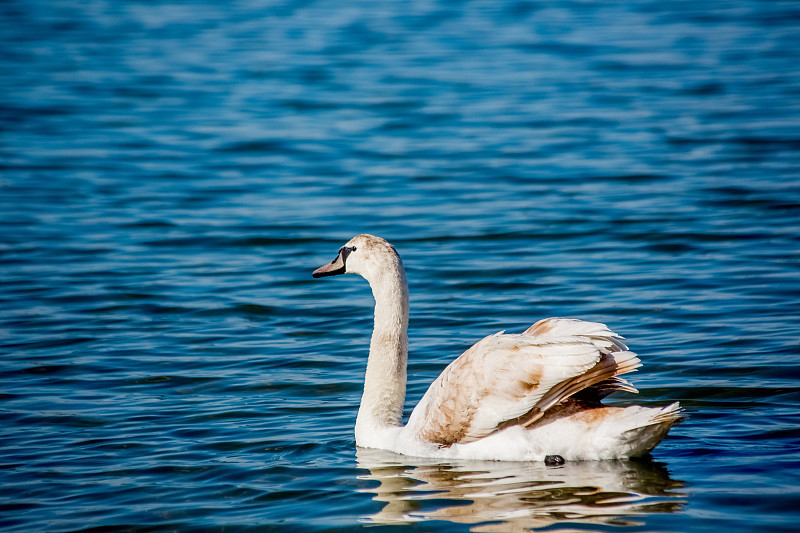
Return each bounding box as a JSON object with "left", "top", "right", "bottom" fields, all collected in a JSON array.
[{"left": 407, "top": 318, "right": 641, "bottom": 447}]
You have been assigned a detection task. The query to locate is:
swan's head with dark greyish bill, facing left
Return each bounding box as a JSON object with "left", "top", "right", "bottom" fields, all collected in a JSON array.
[{"left": 312, "top": 233, "right": 404, "bottom": 282}]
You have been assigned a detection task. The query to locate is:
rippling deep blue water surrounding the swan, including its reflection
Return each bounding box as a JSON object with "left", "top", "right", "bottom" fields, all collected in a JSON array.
[{"left": 0, "top": 0, "right": 800, "bottom": 532}]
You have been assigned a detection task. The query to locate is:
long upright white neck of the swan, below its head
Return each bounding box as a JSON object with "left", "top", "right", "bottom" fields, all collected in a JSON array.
[{"left": 355, "top": 262, "right": 408, "bottom": 448}]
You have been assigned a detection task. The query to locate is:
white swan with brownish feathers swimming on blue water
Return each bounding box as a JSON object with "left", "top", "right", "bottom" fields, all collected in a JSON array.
[{"left": 312, "top": 234, "right": 683, "bottom": 464}]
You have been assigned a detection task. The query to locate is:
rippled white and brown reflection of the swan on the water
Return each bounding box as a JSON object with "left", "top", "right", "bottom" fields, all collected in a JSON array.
[{"left": 356, "top": 448, "right": 685, "bottom": 532}]
